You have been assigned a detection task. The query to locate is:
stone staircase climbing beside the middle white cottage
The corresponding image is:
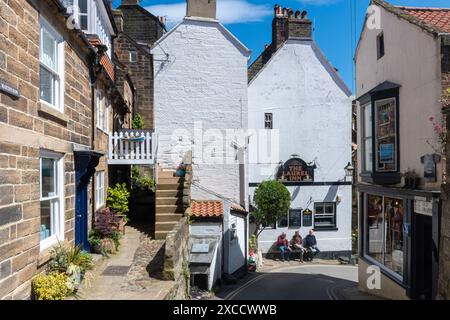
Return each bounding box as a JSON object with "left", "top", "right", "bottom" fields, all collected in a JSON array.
[{"left": 155, "top": 171, "right": 184, "bottom": 239}]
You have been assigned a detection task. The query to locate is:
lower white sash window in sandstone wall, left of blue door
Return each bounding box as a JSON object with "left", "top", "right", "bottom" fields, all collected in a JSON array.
[{"left": 39, "top": 152, "right": 64, "bottom": 250}]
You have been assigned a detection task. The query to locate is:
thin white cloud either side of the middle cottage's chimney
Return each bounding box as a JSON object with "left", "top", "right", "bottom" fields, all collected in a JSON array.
[{"left": 146, "top": 0, "right": 273, "bottom": 27}]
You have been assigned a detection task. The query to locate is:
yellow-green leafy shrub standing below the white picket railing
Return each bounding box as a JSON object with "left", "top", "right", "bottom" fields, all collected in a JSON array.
[{"left": 106, "top": 183, "right": 130, "bottom": 233}]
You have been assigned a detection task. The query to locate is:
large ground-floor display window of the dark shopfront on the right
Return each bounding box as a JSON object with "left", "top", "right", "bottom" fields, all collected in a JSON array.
[{"left": 365, "top": 195, "right": 404, "bottom": 276}]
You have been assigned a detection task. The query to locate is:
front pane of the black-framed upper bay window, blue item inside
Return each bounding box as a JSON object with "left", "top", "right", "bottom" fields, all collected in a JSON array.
[{"left": 375, "top": 98, "right": 397, "bottom": 172}]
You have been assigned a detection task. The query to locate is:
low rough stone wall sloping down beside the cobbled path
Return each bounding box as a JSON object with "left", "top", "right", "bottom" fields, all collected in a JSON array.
[{"left": 163, "top": 217, "right": 190, "bottom": 299}]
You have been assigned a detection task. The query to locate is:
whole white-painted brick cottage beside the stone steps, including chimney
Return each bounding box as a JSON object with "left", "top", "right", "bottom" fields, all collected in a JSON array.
[{"left": 151, "top": 0, "right": 250, "bottom": 285}]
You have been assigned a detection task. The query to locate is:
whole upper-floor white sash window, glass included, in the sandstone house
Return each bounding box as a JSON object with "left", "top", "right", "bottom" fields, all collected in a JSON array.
[{"left": 39, "top": 19, "right": 64, "bottom": 111}]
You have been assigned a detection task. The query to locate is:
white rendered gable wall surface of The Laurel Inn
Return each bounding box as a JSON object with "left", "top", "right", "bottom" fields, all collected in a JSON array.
[{"left": 249, "top": 40, "right": 352, "bottom": 252}]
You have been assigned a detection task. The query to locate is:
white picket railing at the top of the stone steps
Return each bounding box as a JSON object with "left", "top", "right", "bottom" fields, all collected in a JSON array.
[{"left": 108, "top": 131, "right": 158, "bottom": 164}]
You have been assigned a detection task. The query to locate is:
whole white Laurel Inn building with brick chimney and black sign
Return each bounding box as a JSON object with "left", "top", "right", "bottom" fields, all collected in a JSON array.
[{"left": 248, "top": 6, "right": 352, "bottom": 256}]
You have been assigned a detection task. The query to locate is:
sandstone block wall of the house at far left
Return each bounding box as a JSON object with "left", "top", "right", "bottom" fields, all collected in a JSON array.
[{"left": 0, "top": 0, "right": 92, "bottom": 299}]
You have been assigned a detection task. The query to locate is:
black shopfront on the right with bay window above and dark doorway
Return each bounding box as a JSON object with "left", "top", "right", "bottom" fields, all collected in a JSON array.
[{"left": 357, "top": 82, "right": 441, "bottom": 299}]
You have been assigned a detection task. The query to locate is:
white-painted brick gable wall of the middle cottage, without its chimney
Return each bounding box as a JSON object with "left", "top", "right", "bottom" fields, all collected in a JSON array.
[{"left": 152, "top": 19, "right": 249, "bottom": 203}]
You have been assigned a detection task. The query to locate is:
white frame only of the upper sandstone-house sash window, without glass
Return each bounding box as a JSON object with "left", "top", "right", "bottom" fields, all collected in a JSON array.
[{"left": 39, "top": 17, "right": 65, "bottom": 112}]
